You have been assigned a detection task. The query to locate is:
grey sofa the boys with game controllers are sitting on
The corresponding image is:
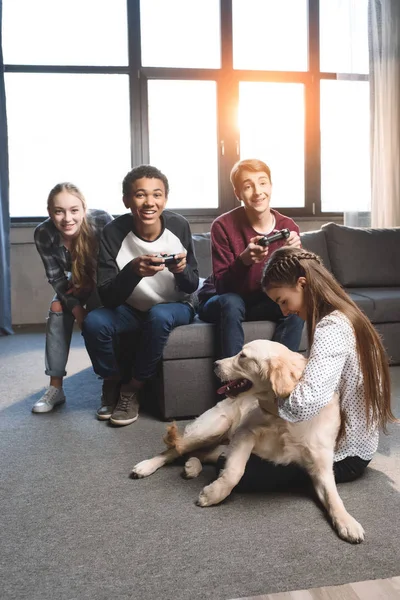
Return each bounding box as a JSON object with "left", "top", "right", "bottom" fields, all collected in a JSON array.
[{"left": 145, "top": 223, "right": 400, "bottom": 420}]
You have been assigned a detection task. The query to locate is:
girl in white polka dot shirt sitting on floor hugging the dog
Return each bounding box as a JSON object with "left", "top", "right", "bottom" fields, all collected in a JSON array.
[{"left": 219, "top": 247, "right": 396, "bottom": 491}]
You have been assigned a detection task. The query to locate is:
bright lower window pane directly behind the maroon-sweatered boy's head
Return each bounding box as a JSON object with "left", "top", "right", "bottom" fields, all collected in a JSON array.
[{"left": 239, "top": 82, "right": 304, "bottom": 207}]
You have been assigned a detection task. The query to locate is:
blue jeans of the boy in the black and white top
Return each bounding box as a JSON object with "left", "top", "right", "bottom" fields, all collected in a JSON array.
[{"left": 82, "top": 302, "right": 194, "bottom": 383}]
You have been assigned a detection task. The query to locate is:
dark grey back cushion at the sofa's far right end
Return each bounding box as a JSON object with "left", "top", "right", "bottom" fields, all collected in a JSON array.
[{"left": 322, "top": 223, "right": 400, "bottom": 287}]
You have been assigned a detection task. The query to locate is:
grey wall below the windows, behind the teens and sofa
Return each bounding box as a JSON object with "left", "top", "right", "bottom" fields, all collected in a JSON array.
[{"left": 10, "top": 219, "right": 338, "bottom": 325}]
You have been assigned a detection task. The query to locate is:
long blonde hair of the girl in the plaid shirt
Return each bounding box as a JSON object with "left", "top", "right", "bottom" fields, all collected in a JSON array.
[{"left": 47, "top": 183, "right": 98, "bottom": 291}]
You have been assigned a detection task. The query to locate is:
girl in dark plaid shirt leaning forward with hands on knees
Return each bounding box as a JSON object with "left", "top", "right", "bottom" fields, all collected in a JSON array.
[{"left": 32, "top": 183, "right": 112, "bottom": 413}]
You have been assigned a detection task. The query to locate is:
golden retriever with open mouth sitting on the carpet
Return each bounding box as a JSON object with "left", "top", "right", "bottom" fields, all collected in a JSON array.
[{"left": 132, "top": 340, "right": 364, "bottom": 543}]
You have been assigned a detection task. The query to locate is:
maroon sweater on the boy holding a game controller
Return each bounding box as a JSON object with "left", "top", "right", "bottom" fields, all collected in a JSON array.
[{"left": 198, "top": 206, "right": 300, "bottom": 302}]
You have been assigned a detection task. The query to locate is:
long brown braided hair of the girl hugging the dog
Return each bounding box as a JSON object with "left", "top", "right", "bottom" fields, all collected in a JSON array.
[{"left": 261, "top": 247, "right": 397, "bottom": 432}]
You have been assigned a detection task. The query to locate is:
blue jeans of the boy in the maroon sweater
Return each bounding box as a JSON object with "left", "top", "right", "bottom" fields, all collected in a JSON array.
[{"left": 198, "top": 292, "right": 304, "bottom": 358}]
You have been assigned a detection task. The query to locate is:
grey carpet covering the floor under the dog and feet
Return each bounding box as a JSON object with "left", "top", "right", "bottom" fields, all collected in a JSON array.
[{"left": 0, "top": 330, "right": 400, "bottom": 600}]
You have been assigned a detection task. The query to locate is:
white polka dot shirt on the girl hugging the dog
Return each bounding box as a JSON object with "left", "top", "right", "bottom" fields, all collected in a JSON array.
[{"left": 278, "top": 310, "right": 378, "bottom": 461}]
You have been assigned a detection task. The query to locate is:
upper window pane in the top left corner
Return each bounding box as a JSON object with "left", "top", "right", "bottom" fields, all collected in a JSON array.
[{"left": 3, "top": 0, "right": 128, "bottom": 66}]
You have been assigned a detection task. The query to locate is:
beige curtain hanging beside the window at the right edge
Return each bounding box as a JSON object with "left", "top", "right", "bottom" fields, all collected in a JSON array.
[{"left": 369, "top": 0, "right": 400, "bottom": 227}]
